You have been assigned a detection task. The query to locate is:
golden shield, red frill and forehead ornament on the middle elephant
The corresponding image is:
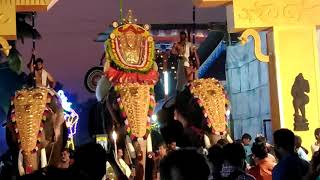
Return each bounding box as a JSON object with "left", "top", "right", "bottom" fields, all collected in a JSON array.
[{"left": 104, "top": 10, "right": 158, "bottom": 139}]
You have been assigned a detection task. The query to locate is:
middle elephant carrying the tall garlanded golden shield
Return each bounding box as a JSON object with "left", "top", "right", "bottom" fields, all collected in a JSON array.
[{"left": 90, "top": 10, "right": 158, "bottom": 180}]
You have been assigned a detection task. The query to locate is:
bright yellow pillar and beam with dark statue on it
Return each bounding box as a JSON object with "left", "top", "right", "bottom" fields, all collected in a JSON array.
[{"left": 194, "top": 0, "right": 320, "bottom": 156}]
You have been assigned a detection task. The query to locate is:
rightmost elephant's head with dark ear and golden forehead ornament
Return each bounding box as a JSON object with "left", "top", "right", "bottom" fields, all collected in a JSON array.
[{"left": 158, "top": 79, "right": 232, "bottom": 148}]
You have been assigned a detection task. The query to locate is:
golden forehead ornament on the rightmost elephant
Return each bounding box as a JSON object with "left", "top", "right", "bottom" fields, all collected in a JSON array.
[{"left": 191, "top": 79, "right": 227, "bottom": 133}]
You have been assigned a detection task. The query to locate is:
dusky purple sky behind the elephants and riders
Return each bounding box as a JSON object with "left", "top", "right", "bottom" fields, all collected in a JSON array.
[{"left": 19, "top": 0, "right": 226, "bottom": 102}]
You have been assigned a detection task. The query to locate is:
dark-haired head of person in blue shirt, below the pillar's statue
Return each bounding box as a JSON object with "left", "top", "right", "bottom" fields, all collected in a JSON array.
[{"left": 273, "top": 129, "right": 295, "bottom": 159}]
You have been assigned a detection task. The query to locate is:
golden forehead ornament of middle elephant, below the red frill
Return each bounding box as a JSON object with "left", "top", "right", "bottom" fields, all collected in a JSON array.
[{"left": 117, "top": 83, "right": 153, "bottom": 138}]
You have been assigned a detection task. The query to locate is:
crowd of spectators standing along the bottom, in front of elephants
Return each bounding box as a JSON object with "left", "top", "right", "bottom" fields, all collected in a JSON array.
[{"left": 0, "top": 128, "right": 320, "bottom": 180}]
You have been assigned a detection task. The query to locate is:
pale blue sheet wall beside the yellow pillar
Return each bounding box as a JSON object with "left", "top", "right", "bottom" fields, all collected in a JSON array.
[{"left": 226, "top": 33, "right": 272, "bottom": 139}]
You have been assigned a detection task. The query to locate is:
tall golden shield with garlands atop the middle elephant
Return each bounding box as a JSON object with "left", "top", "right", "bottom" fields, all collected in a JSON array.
[{"left": 105, "top": 10, "right": 154, "bottom": 73}]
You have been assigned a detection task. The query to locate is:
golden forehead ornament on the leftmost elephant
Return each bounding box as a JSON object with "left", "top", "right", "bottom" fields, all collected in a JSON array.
[{"left": 13, "top": 88, "right": 48, "bottom": 153}]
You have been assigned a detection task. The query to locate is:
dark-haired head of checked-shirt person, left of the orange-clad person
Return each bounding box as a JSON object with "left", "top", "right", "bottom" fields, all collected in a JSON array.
[{"left": 223, "top": 143, "right": 246, "bottom": 168}]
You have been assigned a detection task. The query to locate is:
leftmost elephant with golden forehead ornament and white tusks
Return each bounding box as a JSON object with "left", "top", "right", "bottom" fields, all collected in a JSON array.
[{"left": 7, "top": 87, "right": 67, "bottom": 175}]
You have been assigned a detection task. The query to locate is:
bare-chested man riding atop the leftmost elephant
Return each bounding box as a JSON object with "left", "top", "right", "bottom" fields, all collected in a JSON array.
[{"left": 29, "top": 50, "right": 56, "bottom": 88}]
